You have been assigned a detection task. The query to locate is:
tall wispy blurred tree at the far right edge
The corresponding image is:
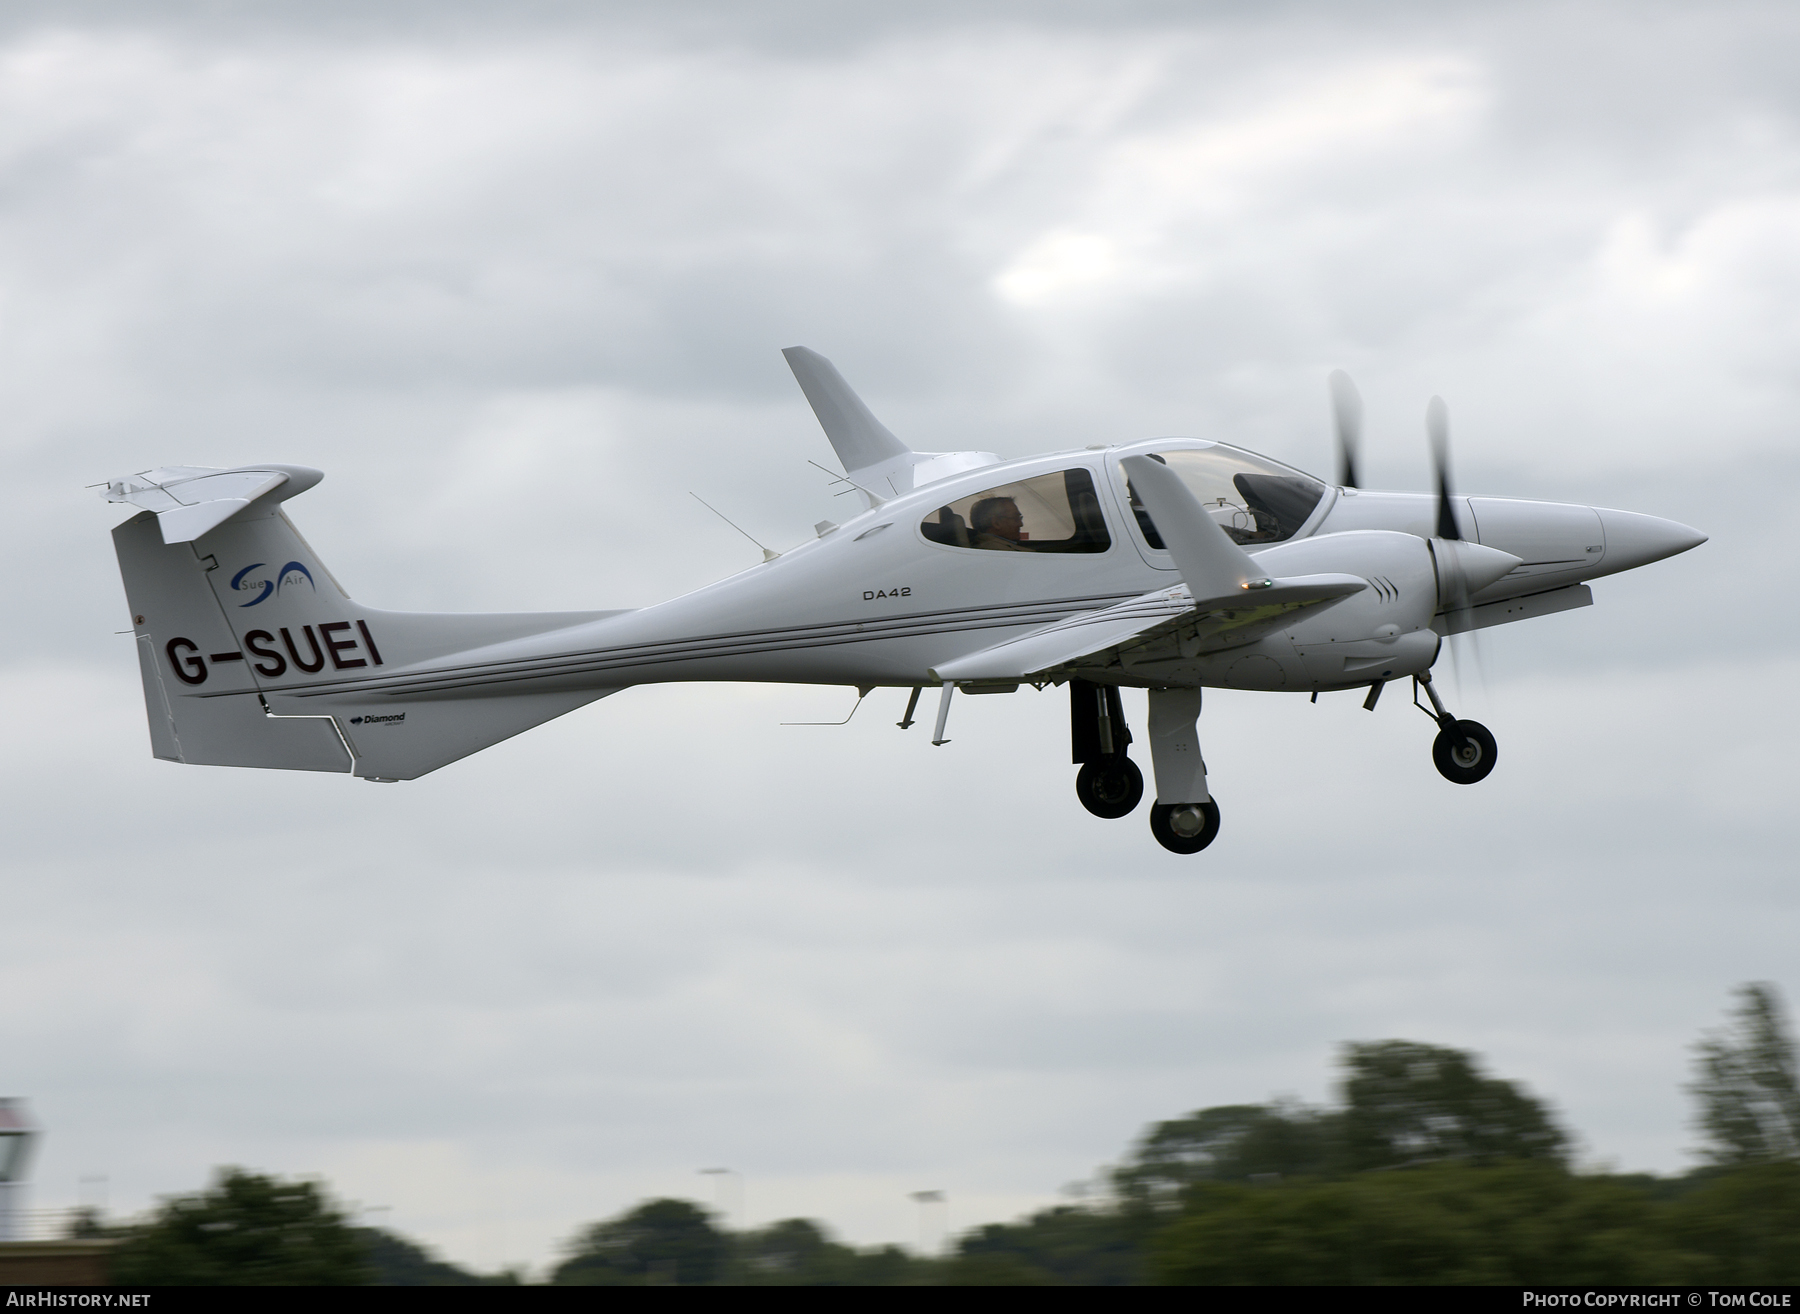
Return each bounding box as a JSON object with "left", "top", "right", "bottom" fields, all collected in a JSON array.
[{"left": 1690, "top": 981, "right": 1800, "bottom": 1165}]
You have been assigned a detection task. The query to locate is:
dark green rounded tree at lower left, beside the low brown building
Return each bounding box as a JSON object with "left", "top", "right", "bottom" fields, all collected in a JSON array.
[{"left": 112, "top": 1168, "right": 373, "bottom": 1287}]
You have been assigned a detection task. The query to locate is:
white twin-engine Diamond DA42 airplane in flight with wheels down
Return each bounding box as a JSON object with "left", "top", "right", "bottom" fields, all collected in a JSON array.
[{"left": 104, "top": 347, "right": 1706, "bottom": 853}]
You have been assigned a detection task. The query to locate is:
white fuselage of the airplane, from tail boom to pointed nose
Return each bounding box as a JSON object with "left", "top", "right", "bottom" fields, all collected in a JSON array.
[{"left": 309, "top": 437, "right": 1705, "bottom": 700}]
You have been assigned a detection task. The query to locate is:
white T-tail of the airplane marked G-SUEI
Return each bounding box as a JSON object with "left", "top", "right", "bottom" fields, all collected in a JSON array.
[{"left": 104, "top": 464, "right": 617, "bottom": 779}]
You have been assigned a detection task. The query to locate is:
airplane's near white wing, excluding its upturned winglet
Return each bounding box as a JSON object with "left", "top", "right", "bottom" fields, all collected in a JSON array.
[{"left": 932, "top": 574, "right": 1368, "bottom": 684}]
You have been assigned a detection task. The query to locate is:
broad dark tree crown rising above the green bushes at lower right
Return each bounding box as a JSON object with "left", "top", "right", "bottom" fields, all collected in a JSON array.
[{"left": 1343, "top": 1040, "right": 1568, "bottom": 1172}]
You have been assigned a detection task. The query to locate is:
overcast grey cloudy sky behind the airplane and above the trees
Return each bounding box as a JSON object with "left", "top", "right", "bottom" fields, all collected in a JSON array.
[{"left": 0, "top": 0, "right": 1800, "bottom": 1267}]
